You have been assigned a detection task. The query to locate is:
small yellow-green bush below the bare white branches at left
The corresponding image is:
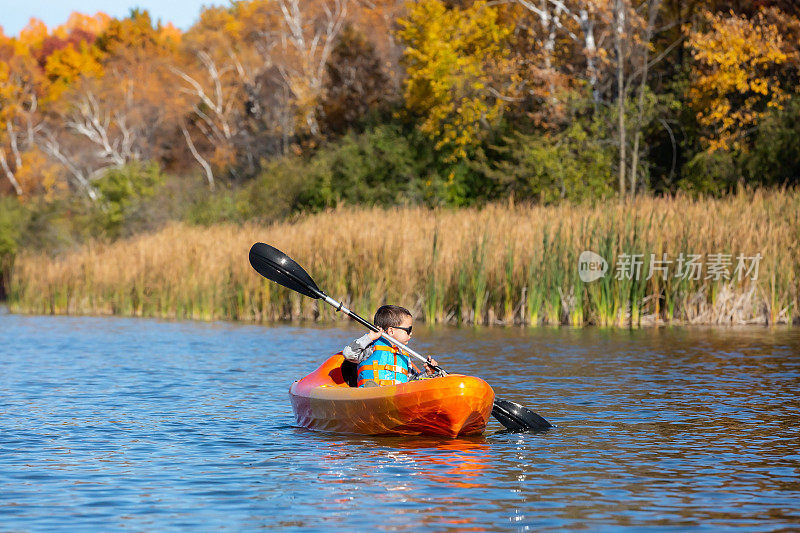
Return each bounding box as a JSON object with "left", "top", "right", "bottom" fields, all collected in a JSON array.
[{"left": 91, "top": 162, "right": 164, "bottom": 238}]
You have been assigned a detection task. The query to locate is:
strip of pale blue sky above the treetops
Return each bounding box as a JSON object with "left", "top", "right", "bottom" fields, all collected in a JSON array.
[{"left": 0, "top": 0, "right": 222, "bottom": 36}]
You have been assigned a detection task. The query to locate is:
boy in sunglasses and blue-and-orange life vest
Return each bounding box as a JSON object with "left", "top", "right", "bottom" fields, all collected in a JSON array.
[{"left": 342, "top": 305, "right": 437, "bottom": 387}]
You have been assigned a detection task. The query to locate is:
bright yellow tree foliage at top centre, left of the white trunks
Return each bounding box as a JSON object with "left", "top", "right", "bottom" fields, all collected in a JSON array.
[{"left": 399, "top": 0, "right": 512, "bottom": 158}]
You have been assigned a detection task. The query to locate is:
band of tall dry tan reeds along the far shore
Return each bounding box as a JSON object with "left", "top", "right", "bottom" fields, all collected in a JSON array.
[{"left": 9, "top": 191, "right": 800, "bottom": 325}]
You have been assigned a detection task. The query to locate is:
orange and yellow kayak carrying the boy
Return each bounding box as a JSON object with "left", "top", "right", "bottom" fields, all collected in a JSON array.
[{"left": 289, "top": 353, "right": 494, "bottom": 438}]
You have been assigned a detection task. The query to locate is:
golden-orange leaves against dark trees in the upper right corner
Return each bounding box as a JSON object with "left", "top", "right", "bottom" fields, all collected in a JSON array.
[{"left": 688, "top": 12, "right": 789, "bottom": 152}]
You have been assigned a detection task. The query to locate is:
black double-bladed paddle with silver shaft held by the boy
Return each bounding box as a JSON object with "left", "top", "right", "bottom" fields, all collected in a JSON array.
[{"left": 250, "top": 242, "right": 552, "bottom": 431}]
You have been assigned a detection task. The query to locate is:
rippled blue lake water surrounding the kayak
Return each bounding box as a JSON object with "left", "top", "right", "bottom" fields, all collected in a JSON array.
[{"left": 0, "top": 314, "right": 800, "bottom": 531}]
